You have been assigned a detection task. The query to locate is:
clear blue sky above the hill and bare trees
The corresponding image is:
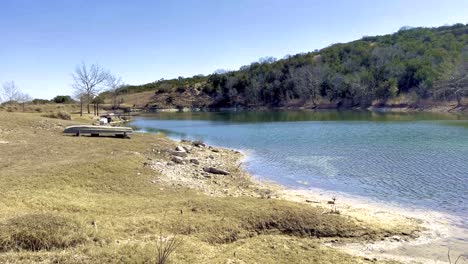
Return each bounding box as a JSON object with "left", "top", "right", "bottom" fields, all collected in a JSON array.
[{"left": 0, "top": 0, "right": 468, "bottom": 98}]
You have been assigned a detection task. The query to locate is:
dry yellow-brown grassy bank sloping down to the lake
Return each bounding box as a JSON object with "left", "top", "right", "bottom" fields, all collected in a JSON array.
[{"left": 0, "top": 111, "right": 417, "bottom": 263}]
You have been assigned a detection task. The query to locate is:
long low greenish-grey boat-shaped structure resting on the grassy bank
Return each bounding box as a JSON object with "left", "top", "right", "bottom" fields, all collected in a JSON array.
[{"left": 63, "top": 125, "right": 133, "bottom": 137}]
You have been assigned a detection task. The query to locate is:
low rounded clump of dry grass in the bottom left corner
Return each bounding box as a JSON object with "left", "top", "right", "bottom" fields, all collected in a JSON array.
[{"left": 0, "top": 214, "right": 87, "bottom": 251}]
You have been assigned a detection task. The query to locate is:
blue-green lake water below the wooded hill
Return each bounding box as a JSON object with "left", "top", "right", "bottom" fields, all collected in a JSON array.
[{"left": 132, "top": 111, "right": 468, "bottom": 225}]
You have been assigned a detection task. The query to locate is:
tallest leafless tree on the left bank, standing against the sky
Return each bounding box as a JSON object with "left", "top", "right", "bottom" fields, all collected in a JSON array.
[{"left": 72, "top": 63, "right": 108, "bottom": 114}]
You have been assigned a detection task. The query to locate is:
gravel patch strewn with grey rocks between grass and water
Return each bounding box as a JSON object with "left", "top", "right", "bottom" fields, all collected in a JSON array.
[{"left": 147, "top": 140, "right": 274, "bottom": 198}]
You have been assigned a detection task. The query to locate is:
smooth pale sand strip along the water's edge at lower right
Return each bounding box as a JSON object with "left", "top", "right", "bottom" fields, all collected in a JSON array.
[{"left": 246, "top": 163, "right": 468, "bottom": 263}]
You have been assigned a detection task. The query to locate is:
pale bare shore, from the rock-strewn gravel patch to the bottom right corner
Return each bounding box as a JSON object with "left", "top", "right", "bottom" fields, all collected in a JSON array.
[{"left": 144, "top": 141, "right": 468, "bottom": 263}]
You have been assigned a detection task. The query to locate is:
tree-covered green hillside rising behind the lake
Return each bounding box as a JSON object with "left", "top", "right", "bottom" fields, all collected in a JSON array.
[{"left": 105, "top": 24, "right": 468, "bottom": 109}]
